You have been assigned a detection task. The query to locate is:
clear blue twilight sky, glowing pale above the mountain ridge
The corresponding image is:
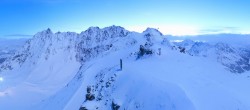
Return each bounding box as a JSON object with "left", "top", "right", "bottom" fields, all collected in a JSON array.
[{"left": 0, "top": 0, "right": 250, "bottom": 37}]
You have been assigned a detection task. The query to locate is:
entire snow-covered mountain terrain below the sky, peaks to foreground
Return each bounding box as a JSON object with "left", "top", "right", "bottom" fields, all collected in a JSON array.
[{"left": 0, "top": 26, "right": 250, "bottom": 110}]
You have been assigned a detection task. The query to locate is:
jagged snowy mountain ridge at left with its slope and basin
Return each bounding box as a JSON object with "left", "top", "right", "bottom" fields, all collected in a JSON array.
[{"left": 0, "top": 26, "right": 135, "bottom": 109}]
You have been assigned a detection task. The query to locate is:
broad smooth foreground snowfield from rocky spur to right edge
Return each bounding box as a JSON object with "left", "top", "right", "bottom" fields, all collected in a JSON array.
[{"left": 65, "top": 45, "right": 250, "bottom": 110}]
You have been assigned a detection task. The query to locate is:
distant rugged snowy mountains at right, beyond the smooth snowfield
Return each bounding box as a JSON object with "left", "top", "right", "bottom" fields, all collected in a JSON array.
[{"left": 175, "top": 39, "right": 250, "bottom": 73}]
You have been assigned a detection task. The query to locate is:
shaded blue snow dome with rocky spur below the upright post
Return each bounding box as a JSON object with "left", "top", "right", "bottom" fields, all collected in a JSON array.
[{"left": 61, "top": 48, "right": 194, "bottom": 110}]
